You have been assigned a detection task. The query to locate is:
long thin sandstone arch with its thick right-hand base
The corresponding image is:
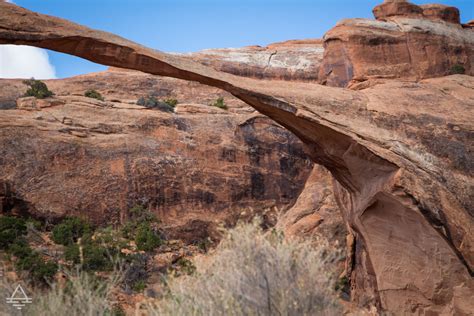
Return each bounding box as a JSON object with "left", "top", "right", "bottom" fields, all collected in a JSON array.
[{"left": 0, "top": 3, "right": 474, "bottom": 312}]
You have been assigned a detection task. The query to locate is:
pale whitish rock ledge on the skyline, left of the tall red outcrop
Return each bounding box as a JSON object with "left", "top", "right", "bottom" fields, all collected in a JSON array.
[{"left": 184, "top": 39, "right": 324, "bottom": 81}]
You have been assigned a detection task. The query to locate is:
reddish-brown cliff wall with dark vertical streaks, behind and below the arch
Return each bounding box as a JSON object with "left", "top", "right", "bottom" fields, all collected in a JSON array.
[{"left": 0, "top": 71, "right": 312, "bottom": 241}]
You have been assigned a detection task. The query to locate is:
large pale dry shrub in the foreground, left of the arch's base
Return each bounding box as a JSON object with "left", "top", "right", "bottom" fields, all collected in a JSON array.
[{"left": 149, "top": 218, "right": 342, "bottom": 315}]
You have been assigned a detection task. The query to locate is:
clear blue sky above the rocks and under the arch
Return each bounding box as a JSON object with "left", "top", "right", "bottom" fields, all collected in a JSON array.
[{"left": 7, "top": 0, "right": 474, "bottom": 78}]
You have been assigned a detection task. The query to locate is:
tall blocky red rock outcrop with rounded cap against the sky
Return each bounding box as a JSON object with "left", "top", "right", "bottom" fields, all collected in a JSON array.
[{"left": 319, "top": 1, "right": 474, "bottom": 87}]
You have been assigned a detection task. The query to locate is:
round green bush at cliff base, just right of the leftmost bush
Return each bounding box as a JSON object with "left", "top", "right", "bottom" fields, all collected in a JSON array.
[{"left": 52, "top": 217, "right": 90, "bottom": 246}]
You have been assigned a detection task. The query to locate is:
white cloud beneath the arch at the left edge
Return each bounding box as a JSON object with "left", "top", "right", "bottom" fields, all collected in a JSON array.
[{"left": 0, "top": 45, "right": 56, "bottom": 79}]
